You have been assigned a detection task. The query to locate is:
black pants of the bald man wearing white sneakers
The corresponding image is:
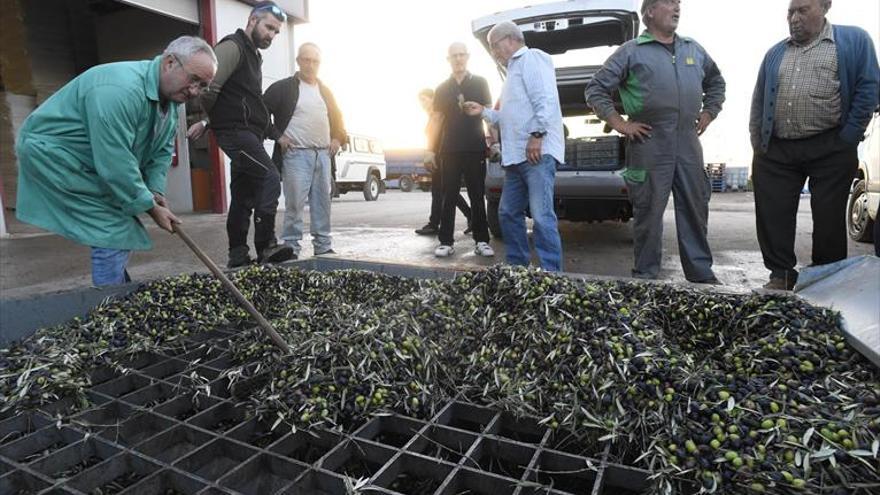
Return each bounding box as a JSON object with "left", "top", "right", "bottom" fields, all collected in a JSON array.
[{"left": 438, "top": 152, "right": 489, "bottom": 246}]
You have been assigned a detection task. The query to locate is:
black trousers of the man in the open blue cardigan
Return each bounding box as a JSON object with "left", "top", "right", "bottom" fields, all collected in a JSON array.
[{"left": 752, "top": 129, "right": 859, "bottom": 281}]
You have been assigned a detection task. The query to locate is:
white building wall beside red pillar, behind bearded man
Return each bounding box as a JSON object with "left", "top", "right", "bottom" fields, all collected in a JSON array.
[{"left": 216, "top": 0, "right": 296, "bottom": 207}]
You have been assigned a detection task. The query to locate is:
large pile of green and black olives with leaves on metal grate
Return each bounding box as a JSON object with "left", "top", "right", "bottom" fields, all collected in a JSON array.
[{"left": 0, "top": 266, "right": 880, "bottom": 494}]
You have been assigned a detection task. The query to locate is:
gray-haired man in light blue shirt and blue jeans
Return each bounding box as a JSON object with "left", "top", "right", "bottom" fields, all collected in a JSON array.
[{"left": 463, "top": 21, "right": 565, "bottom": 271}]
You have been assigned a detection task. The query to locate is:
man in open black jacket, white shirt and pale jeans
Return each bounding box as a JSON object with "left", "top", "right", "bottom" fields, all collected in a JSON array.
[{"left": 263, "top": 43, "right": 348, "bottom": 256}]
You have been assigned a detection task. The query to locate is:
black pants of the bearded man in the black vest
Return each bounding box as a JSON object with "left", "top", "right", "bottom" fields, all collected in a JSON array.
[{"left": 215, "top": 130, "right": 281, "bottom": 254}]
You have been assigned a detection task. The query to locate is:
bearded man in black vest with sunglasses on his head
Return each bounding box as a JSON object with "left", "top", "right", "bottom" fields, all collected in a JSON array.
[{"left": 187, "top": 2, "right": 294, "bottom": 268}]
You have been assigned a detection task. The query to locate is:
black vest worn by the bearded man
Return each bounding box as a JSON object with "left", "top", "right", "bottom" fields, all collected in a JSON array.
[{"left": 209, "top": 29, "right": 269, "bottom": 138}]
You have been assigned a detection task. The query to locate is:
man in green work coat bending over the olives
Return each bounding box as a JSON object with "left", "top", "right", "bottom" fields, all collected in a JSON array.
[{"left": 15, "top": 36, "right": 217, "bottom": 286}]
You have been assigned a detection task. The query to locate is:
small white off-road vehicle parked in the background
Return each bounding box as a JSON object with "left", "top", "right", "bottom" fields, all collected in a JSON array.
[{"left": 335, "top": 134, "right": 387, "bottom": 201}]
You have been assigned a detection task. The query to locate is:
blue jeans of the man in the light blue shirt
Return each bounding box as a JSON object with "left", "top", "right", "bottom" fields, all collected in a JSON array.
[{"left": 498, "top": 155, "right": 562, "bottom": 272}]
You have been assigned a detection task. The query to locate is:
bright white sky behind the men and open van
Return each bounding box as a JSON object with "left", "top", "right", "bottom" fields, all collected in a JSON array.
[{"left": 295, "top": 0, "right": 880, "bottom": 166}]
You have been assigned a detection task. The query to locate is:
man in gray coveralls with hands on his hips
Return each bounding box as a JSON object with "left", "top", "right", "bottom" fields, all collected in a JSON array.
[{"left": 586, "top": 0, "right": 725, "bottom": 284}]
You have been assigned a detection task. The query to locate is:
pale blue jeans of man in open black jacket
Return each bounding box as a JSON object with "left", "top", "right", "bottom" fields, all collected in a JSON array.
[{"left": 281, "top": 148, "right": 331, "bottom": 256}]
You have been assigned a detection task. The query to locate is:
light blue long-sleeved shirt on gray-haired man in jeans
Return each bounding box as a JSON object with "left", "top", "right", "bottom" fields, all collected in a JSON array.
[{"left": 483, "top": 46, "right": 565, "bottom": 166}]
